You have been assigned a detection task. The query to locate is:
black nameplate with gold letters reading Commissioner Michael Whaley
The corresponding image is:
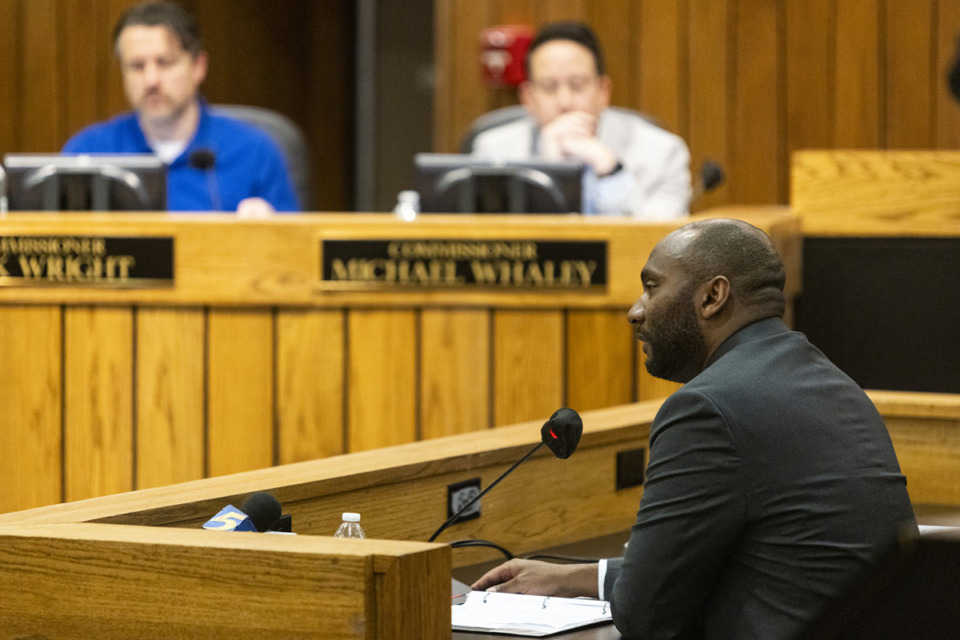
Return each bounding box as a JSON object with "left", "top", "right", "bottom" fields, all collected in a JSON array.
[{"left": 321, "top": 239, "right": 607, "bottom": 290}]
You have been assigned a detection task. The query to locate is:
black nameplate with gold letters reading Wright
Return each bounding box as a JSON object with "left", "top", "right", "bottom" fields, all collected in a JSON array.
[{"left": 0, "top": 235, "right": 174, "bottom": 289}]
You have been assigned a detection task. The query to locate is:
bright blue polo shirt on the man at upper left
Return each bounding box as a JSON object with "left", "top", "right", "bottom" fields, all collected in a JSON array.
[{"left": 63, "top": 103, "right": 300, "bottom": 211}]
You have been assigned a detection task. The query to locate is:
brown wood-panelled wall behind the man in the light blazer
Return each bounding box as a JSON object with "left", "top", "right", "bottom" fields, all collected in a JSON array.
[{"left": 435, "top": 0, "right": 960, "bottom": 210}]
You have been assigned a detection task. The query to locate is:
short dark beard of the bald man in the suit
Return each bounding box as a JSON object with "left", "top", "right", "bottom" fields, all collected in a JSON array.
[{"left": 644, "top": 286, "right": 707, "bottom": 384}]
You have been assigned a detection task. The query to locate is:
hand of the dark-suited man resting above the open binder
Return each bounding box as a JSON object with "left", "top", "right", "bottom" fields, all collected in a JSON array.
[{"left": 471, "top": 559, "right": 599, "bottom": 598}]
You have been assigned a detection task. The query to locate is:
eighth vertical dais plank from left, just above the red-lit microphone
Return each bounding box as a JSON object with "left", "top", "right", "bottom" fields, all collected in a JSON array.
[{"left": 493, "top": 311, "right": 565, "bottom": 426}]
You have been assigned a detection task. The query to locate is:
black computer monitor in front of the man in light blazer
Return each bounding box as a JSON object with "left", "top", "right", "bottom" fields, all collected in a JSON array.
[{"left": 414, "top": 153, "right": 584, "bottom": 213}]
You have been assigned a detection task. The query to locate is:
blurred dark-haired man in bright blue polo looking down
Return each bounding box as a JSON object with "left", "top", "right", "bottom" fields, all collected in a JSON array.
[{"left": 63, "top": 2, "right": 300, "bottom": 217}]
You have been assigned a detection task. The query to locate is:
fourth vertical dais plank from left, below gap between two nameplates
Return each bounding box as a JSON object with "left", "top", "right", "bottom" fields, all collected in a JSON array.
[{"left": 207, "top": 309, "right": 275, "bottom": 476}]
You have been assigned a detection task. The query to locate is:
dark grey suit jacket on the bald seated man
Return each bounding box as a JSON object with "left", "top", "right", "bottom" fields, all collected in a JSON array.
[{"left": 604, "top": 318, "right": 916, "bottom": 640}]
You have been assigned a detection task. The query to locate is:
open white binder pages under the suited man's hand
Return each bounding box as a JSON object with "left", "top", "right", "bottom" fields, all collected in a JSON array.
[{"left": 452, "top": 591, "right": 611, "bottom": 637}]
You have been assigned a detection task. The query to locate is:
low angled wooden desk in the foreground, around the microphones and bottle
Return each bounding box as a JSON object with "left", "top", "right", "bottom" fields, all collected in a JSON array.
[{"left": 0, "top": 392, "right": 960, "bottom": 639}]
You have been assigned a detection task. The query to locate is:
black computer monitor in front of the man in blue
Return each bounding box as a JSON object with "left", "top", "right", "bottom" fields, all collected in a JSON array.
[{"left": 3, "top": 153, "right": 167, "bottom": 211}]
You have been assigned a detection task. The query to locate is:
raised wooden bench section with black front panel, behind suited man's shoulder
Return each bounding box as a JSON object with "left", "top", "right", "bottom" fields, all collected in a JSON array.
[{"left": 790, "top": 150, "right": 960, "bottom": 393}]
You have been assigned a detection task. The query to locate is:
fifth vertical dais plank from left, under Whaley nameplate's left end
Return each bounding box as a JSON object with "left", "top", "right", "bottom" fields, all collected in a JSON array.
[{"left": 277, "top": 310, "right": 347, "bottom": 464}]
